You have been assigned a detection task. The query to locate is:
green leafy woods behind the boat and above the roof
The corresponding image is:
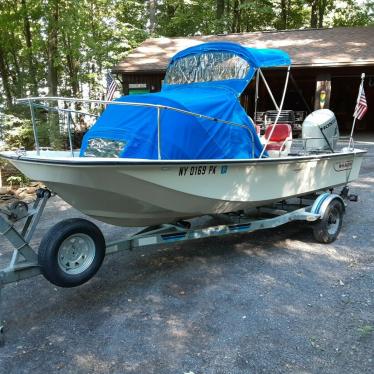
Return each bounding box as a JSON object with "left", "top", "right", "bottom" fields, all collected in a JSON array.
[{"left": 0, "top": 0, "right": 374, "bottom": 142}]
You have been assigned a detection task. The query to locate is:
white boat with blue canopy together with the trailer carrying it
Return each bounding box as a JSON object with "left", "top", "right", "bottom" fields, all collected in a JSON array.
[{"left": 0, "top": 42, "right": 365, "bottom": 334}]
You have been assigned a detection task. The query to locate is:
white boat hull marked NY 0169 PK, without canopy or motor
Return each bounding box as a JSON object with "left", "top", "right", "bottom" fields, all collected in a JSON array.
[{"left": 2, "top": 150, "right": 365, "bottom": 226}]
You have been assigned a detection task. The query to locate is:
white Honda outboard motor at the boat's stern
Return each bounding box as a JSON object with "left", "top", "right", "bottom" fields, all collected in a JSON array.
[{"left": 302, "top": 109, "right": 339, "bottom": 152}]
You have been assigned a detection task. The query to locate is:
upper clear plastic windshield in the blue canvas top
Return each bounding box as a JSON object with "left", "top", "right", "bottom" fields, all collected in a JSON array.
[{"left": 165, "top": 51, "right": 250, "bottom": 84}]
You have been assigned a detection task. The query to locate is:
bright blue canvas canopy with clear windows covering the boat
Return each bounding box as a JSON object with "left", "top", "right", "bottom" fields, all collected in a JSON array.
[{"left": 80, "top": 42, "right": 290, "bottom": 160}]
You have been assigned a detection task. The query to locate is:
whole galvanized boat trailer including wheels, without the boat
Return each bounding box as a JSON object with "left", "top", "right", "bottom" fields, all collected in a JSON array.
[{"left": 0, "top": 187, "right": 357, "bottom": 345}]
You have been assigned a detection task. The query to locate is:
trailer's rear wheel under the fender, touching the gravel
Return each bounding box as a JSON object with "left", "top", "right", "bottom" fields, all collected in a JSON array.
[{"left": 313, "top": 200, "right": 344, "bottom": 243}]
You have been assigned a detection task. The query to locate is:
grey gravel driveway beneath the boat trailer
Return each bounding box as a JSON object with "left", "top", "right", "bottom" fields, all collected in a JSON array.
[{"left": 0, "top": 143, "right": 374, "bottom": 374}]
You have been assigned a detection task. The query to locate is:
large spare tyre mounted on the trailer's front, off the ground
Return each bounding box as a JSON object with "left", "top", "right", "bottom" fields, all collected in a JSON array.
[{"left": 38, "top": 218, "right": 105, "bottom": 287}]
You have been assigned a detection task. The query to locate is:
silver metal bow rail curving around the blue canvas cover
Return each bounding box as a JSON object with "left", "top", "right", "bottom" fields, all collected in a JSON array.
[{"left": 16, "top": 96, "right": 254, "bottom": 160}]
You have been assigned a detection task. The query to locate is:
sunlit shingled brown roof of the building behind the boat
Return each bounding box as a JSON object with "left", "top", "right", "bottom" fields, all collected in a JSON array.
[{"left": 112, "top": 27, "right": 374, "bottom": 73}]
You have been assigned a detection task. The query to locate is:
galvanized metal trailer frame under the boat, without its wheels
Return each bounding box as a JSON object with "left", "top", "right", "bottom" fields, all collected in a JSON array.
[{"left": 0, "top": 188, "right": 346, "bottom": 346}]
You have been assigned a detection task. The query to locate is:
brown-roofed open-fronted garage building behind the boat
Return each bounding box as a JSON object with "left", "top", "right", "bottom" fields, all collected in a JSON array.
[{"left": 112, "top": 27, "right": 374, "bottom": 132}]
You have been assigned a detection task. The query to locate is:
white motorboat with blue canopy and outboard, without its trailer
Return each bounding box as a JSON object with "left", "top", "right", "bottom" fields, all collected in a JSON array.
[{"left": 1, "top": 42, "right": 365, "bottom": 226}]
